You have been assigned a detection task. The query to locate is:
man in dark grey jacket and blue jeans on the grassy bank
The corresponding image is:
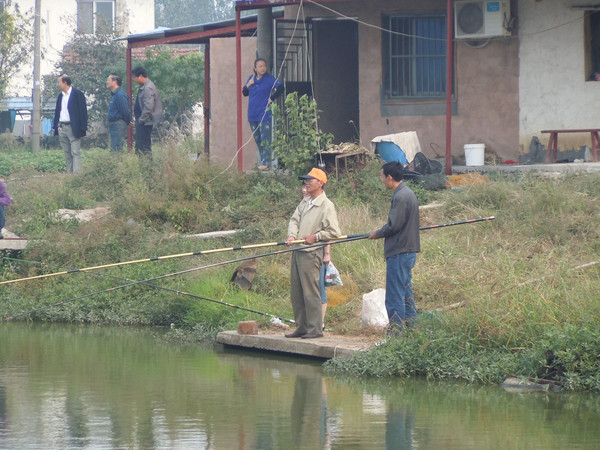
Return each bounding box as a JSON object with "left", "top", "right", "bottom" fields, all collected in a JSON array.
[{"left": 369, "top": 161, "right": 421, "bottom": 335}]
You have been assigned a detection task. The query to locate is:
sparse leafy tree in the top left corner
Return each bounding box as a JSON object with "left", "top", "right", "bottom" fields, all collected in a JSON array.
[{"left": 0, "top": 2, "right": 33, "bottom": 97}]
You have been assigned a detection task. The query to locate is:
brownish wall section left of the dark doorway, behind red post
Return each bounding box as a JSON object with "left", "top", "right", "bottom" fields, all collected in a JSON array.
[{"left": 210, "top": 38, "right": 257, "bottom": 170}]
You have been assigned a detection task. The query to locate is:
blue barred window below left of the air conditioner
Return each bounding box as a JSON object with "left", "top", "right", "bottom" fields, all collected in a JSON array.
[{"left": 382, "top": 13, "right": 446, "bottom": 100}]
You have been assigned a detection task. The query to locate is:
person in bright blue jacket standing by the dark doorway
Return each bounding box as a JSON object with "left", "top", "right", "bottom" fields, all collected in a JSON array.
[{"left": 242, "top": 58, "right": 283, "bottom": 170}]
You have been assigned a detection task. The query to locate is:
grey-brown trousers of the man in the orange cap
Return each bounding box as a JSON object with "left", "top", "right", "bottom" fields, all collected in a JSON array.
[{"left": 290, "top": 249, "right": 323, "bottom": 334}]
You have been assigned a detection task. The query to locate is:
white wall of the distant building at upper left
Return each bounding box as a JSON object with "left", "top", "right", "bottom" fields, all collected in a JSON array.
[{"left": 7, "top": 0, "right": 154, "bottom": 96}]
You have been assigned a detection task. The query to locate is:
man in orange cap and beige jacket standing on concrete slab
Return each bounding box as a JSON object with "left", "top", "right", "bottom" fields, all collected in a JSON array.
[{"left": 285, "top": 167, "right": 341, "bottom": 339}]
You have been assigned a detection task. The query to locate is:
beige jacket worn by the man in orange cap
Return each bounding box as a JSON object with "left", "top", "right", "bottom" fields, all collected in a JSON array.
[{"left": 288, "top": 192, "right": 342, "bottom": 251}]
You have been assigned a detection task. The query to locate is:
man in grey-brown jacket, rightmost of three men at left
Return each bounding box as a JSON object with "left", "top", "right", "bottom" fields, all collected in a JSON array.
[{"left": 132, "top": 66, "right": 163, "bottom": 157}]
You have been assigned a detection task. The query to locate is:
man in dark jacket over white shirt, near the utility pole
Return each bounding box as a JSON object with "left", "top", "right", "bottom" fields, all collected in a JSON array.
[{"left": 52, "top": 74, "right": 88, "bottom": 173}]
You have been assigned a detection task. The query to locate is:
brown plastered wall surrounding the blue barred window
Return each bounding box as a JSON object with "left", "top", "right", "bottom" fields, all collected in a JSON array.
[{"left": 286, "top": 0, "right": 519, "bottom": 159}]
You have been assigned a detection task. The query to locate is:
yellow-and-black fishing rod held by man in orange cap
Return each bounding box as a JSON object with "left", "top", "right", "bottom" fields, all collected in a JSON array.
[{"left": 0, "top": 234, "right": 369, "bottom": 285}]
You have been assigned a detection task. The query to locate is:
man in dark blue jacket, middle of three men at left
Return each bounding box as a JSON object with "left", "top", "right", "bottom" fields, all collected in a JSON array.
[{"left": 106, "top": 73, "right": 131, "bottom": 153}]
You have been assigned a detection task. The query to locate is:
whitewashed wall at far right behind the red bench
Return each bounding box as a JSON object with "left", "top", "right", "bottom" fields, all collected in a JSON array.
[{"left": 518, "top": 0, "right": 600, "bottom": 153}]
